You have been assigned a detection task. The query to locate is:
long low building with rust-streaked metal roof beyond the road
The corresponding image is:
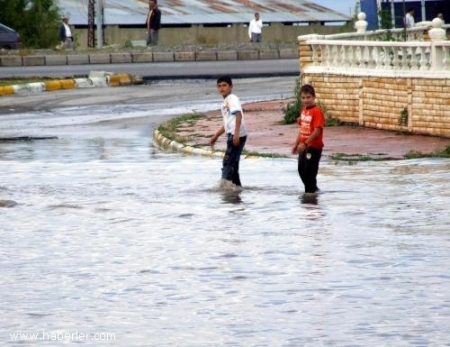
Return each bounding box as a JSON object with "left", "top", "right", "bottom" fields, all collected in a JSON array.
[{"left": 59, "top": 0, "right": 351, "bottom": 46}]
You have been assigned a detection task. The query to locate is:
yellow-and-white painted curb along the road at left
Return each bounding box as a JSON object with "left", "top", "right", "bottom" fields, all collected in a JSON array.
[{"left": 0, "top": 71, "right": 144, "bottom": 96}]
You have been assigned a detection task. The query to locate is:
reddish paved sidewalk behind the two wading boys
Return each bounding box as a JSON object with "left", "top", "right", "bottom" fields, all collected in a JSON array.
[{"left": 171, "top": 100, "right": 450, "bottom": 160}]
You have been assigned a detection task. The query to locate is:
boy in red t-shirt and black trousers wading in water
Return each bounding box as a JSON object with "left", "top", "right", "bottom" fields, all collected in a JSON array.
[{"left": 292, "top": 84, "right": 325, "bottom": 193}]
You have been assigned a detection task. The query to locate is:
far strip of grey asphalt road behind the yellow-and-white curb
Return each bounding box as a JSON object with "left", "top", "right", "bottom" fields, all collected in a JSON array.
[{"left": 0, "top": 59, "right": 300, "bottom": 81}]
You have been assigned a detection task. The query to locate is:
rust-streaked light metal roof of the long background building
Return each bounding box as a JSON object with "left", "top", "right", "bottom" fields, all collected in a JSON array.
[{"left": 58, "top": 0, "right": 351, "bottom": 25}]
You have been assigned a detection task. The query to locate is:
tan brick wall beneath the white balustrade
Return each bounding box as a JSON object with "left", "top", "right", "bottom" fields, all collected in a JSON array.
[{"left": 299, "top": 42, "right": 450, "bottom": 138}]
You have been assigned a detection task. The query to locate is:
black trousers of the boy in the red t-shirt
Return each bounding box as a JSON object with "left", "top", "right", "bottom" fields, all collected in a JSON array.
[{"left": 298, "top": 147, "right": 322, "bottom": 193}]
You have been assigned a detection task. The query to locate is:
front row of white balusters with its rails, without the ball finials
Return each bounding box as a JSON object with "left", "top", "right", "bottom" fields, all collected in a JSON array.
[{"left": 306, "top": 39, "right": 450, "bottom": 72}]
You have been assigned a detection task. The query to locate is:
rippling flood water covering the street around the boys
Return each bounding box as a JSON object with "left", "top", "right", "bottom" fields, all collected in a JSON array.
[{"left": 0, "top": 83, "right": 450, "bottom": 347}]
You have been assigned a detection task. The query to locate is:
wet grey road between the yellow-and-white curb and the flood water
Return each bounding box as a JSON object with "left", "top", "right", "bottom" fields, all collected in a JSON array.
[{"left": 0, "top": 76, "right": 296, "bottom": 115}]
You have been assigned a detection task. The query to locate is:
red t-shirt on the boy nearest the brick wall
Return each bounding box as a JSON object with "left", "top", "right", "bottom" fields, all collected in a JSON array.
[{"left": 297, "top": 105, "right": 325, "bottom": 149}]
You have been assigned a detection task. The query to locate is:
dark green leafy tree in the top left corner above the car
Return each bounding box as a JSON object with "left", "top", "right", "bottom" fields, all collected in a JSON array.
[{"left": 0, "top": 0, "right": 62, "bottom": 48}]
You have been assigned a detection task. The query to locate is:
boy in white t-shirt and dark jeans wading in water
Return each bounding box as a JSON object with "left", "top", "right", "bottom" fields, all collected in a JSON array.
[{"left": 209, "top": 76, "right": 247, "bottom": 187}]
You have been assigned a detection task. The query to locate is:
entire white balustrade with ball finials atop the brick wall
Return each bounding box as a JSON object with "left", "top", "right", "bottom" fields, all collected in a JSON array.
[{"left": 299, "top": 13, "right": 450, "bottom": 78}]
